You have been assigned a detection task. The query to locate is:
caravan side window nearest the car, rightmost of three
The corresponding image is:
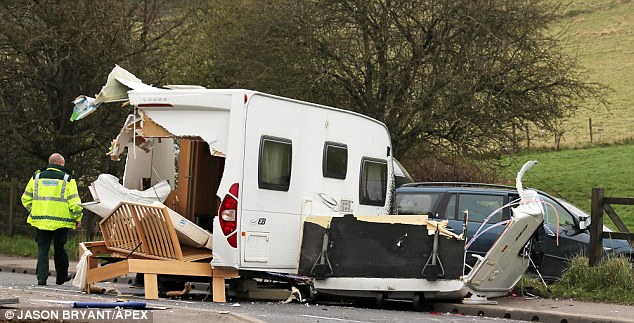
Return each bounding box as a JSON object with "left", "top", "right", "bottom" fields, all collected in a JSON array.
[{"left": 359, "top": 158, "right": 387, "bottom": 206}]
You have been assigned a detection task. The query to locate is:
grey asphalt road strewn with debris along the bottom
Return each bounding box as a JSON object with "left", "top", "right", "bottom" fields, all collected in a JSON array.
[{"left": 0, "top": 272, "right": 517, "bottom": 323}]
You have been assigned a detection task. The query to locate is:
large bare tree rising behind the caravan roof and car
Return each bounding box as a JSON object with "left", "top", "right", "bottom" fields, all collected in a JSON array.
[{"left": 181, "top": 0, "right": 601, "bottom": 163}]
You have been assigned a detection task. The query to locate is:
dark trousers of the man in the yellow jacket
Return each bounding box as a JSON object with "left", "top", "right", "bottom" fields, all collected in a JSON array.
[{"left": 35, "top": 228, "right": 68, "bottom": 283}]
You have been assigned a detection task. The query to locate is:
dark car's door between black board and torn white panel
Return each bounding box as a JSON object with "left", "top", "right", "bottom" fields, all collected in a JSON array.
[{"left": 436, "top": 192, "right": 508, "bottom": 272}]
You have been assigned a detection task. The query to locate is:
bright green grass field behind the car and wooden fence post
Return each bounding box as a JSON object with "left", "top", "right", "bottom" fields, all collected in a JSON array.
[{"left": 504, "top": 144, "right": 634, "bottom": 231}]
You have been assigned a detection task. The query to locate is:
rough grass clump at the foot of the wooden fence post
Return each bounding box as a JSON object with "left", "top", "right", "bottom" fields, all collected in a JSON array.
[{"left": 515, "top": 257, "right": 634, "bottom": 305}]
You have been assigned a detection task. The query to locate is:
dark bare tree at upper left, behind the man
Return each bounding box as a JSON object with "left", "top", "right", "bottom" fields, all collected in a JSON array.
[{"left": 0, "top": 0, "right": 195, "bottom": 179}]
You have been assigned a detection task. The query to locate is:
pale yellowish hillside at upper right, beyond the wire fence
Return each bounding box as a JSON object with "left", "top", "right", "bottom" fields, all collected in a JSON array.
[{"left": 534, "top": 0, "right": 634, "bottom": 147}]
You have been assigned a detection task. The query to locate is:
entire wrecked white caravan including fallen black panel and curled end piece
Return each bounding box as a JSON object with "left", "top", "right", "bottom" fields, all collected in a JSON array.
[{"left": 78, "top": 67, "right": 543, "bottom": 308}]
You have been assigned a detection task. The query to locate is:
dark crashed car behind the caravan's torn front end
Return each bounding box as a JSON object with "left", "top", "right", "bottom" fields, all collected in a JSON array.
[{"left": 396, "top": 182, "right": 634, "bottom": 281}]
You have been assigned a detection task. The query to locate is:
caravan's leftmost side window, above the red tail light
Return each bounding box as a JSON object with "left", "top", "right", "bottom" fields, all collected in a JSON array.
[{"left": 258, "top": 136, "right": 293, "bottom": 191}]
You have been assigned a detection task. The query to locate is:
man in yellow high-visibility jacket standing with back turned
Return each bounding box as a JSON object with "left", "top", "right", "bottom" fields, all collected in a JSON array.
[{"left": 22, "top": 153, "right": 83, "bottom": 285}]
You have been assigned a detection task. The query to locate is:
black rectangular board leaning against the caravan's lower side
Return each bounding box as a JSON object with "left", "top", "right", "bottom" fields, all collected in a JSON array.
[{"left": 299, "top": 216, "right": 464, "bottom": 279}]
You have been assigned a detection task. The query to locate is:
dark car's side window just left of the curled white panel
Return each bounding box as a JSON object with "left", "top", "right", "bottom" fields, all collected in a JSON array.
[{"left": 458, "top": 194, "right": 504, "bottom": 223}]
